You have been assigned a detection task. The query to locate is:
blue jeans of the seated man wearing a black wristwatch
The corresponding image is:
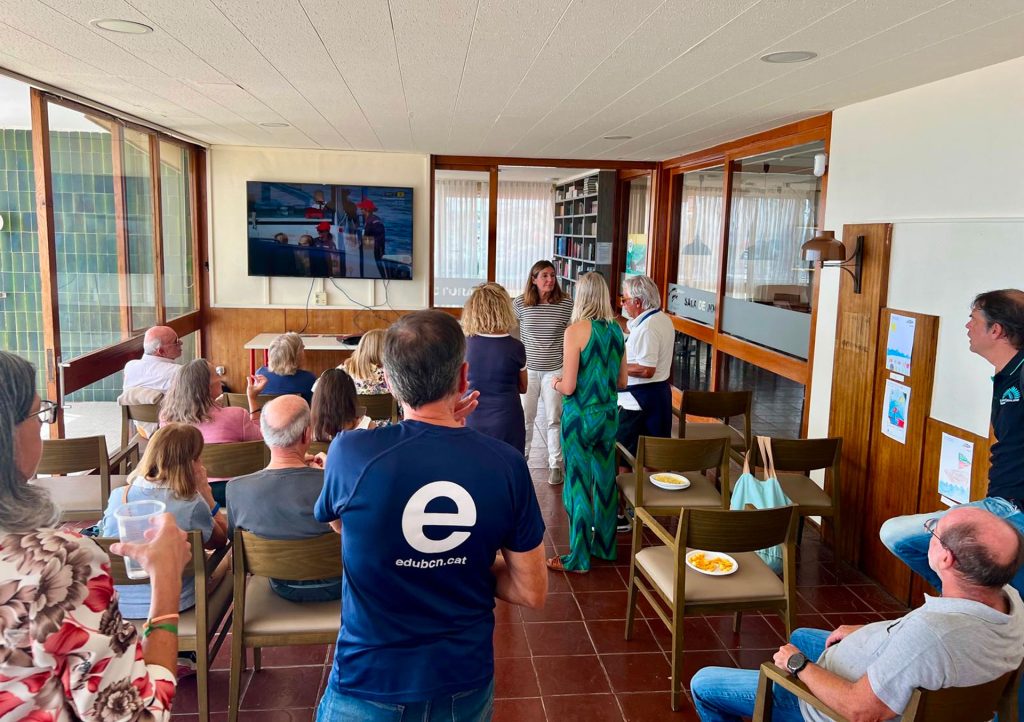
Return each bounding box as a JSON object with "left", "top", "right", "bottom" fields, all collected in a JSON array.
[{"left": 690, "top": 629, "right": 829, "bottom": 722}]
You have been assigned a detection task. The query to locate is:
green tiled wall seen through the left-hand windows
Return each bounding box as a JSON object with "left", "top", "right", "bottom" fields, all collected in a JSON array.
[{"left": 0, "top": 129, "right": 189, "bottom": 402}]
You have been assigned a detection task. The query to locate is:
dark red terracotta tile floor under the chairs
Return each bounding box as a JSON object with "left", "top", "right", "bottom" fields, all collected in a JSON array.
[{"left": 167, "top": 413, "right": 903, "bottom": 722}]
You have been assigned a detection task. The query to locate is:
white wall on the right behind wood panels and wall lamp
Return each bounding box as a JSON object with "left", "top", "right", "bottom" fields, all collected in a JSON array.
[{"left": 808, "top": 53, "right": 1024, "bottom": 436}]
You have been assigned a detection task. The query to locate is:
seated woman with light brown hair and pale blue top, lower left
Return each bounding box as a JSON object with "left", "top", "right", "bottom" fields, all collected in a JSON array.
[{"left": 99, "top": 424, "right": 227, "bottom": 619}]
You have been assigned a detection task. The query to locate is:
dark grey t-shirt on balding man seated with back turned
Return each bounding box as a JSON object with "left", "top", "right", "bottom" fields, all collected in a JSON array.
[{"left": 225, "top": 468, "right": 331, "bottom": 539}]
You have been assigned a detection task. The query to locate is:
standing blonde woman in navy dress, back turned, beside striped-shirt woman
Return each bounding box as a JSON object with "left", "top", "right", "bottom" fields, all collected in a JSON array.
[{"left": 462, "top": 284, "right": 526, "bottom": 450}]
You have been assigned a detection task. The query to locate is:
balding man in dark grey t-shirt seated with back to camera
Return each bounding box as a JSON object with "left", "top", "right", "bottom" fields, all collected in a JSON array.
[{"left": 226, "top": 395, "right": 341, "bottom": 602}]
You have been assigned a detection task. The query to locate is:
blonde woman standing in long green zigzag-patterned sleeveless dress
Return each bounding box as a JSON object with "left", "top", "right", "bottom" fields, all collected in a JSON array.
[{"left": 548, "top": 273, "right": 626, "bottom": 574}]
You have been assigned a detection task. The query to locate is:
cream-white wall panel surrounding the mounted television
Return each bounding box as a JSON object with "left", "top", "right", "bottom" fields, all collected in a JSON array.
[{"left": 209, "top": 145, "right": 430, "bottom": 309}]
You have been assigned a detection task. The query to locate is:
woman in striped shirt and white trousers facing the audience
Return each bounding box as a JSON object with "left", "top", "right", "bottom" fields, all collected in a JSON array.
[{"left": 512, "top": 261, "right": 572, "bottom": 484}]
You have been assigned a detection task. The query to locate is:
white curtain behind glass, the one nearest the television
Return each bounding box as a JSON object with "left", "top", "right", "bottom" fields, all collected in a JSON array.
[{"left": 434, "top": 178, "right": 487, "bottom": 281}]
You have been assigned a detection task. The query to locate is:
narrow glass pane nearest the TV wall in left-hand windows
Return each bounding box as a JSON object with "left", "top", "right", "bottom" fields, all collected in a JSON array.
[{"left": 160, "top": 140, "right": 196, "bottom": 320}]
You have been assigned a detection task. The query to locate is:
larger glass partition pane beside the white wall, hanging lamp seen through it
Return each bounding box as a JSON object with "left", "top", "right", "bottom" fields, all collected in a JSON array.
[{"left": 722, "top": 141, "right": 824, "bottom": 358}]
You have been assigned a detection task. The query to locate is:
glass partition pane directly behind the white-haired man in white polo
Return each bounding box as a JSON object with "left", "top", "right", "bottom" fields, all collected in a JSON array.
[{"left": 668, "top": 166, "right": 725, "bottom": 326}]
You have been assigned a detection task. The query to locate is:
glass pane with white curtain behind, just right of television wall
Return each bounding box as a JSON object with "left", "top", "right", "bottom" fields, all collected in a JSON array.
[{"left": 434, "top": 171, "right": 489, "bottom": 307}]
